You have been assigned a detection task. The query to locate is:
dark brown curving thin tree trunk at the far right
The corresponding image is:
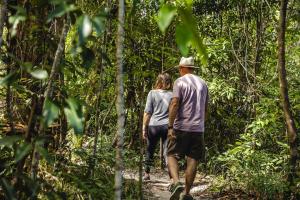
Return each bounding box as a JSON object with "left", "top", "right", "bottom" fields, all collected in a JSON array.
[{"left": 278, "top": 0, "right": 298, "bottom": 184}]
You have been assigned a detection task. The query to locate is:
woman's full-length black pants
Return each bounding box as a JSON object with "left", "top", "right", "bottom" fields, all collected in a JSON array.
[{"left": 145, "top": 124, "right": 168, "bottom": 173}]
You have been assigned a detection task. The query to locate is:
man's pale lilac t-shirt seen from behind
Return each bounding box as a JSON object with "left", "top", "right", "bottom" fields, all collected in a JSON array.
[{"left": 173, "top": 74, "right": 208, "bottom": 132}]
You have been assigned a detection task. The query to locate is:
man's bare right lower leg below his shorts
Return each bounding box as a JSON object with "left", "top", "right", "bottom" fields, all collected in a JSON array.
[{"left": 185, "top": 157, "right": 198, "bottom": 194}]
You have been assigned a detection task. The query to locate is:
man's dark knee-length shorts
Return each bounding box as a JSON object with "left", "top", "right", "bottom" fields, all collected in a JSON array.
[{"left": 167, "top": 130, "right": 205, "bottom": 162}]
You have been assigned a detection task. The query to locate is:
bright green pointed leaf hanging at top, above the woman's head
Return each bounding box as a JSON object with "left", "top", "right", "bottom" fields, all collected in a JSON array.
[{"left": 157, "top": 5, "right": 176, "bottom": 33}]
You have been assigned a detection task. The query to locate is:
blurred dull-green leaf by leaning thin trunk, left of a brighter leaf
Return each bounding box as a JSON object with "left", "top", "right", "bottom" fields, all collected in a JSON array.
[{"left": 43, "top": 98, "right": 59, "bottom": 127}]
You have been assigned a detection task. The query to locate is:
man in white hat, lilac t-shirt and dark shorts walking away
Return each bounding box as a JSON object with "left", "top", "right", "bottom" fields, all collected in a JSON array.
[{"left": 168, "top": 57, "right": 208, "bottom": 200}]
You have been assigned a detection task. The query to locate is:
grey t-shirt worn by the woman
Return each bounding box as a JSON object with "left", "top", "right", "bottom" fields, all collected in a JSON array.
[{"left": 145, "top": 89, "right": 172, "bottom": 126}]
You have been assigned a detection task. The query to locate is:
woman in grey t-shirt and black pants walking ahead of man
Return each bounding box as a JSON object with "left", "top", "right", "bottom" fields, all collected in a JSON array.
[{"left": 143, "top": 73, "right": 172, "bottom": 180}]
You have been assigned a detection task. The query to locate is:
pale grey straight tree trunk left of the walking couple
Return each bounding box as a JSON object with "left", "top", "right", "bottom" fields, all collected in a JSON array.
[{"left": 115, "top": 0, "right": 125, "bottom": 200}]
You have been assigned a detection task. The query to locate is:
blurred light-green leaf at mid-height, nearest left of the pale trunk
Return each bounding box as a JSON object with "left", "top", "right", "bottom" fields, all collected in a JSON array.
[{"left": 64, "top": 98, "right": 83, "bottom": 134}]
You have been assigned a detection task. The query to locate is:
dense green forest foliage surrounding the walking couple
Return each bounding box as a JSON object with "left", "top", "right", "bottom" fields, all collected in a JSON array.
[{"left": 0, "top": 0, "right": 300, "bottom": 199}]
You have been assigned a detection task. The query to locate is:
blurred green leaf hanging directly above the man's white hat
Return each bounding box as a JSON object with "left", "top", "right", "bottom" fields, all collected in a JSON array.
[{"left": 176, "top": 24, "right": 193, "bottom": 56}]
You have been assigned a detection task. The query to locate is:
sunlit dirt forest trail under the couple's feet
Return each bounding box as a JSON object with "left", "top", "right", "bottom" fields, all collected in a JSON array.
[{"left": 124, "top": 170, "right": 213, "bottom": 200}]
